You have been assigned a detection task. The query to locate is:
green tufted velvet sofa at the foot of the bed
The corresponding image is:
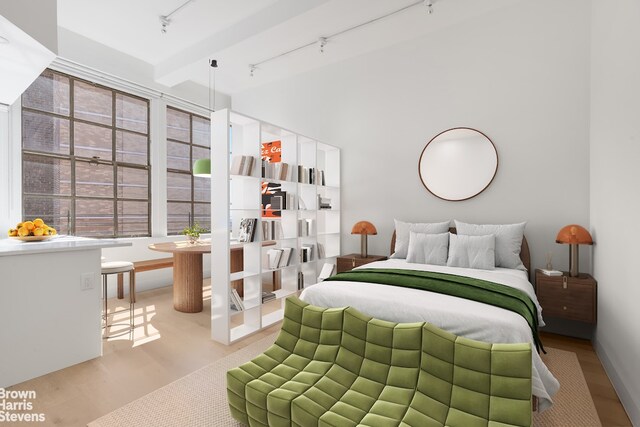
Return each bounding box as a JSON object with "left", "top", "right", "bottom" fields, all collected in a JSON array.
[{"left": 227, "top": 297, "right": 531, "bottom": 427}]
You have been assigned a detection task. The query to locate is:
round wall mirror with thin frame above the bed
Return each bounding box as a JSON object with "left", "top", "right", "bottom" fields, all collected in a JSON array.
[{"left": 418, "top": 128, "right": 498, "bottom": 201}]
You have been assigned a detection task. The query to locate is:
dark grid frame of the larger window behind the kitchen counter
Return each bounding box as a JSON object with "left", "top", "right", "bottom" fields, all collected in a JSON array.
[{"left": 20, "top": 68, "right": 152, "bottom": 238}]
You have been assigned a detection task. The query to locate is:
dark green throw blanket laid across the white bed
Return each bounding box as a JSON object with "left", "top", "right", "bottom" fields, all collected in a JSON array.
[{"left": 325, "top": 268, "right": 546, "bottom": 353}]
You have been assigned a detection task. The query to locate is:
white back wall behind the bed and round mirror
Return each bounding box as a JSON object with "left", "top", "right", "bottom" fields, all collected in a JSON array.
[{"left": 233, "top": 0, "right": 590, "bottom": 271}]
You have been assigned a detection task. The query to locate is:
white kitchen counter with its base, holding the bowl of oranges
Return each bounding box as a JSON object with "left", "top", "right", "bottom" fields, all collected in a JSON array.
[{"left": 0, "top": 236, "right": 131, "bottom": 387}]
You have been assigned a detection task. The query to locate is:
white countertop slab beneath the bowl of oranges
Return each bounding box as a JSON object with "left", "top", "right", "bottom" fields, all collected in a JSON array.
[{"left": 0, "top": 236, "right": 131, "bottom": 257}]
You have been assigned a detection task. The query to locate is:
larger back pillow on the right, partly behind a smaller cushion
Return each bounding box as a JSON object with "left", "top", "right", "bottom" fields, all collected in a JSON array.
[{"left": 455, "top": 221, "right": 527, "bottom": 270}]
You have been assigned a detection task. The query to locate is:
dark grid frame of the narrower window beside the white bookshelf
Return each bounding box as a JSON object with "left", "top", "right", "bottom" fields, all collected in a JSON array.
[{"left": 165, "top": 105, "right": 211, "bottom": 236}]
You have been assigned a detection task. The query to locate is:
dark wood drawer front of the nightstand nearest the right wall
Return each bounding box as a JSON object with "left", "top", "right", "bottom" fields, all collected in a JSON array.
[{"left": 537, "top": 280, "right": 596, "bottom": 323}]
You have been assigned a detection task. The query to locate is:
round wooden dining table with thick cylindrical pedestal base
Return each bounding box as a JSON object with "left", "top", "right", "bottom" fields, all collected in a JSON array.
[{"left": 149, "top": 241, "right": 211, "bottom": 313}]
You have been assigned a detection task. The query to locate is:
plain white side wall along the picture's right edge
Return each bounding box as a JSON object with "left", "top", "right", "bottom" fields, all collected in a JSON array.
[{"left": 591, "top": 0, "right": 640, "bottom": 426}]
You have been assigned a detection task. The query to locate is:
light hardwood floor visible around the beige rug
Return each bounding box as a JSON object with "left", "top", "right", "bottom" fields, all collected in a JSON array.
[{"left": 10, "top": 281, "right": 631, "bottom": 427}]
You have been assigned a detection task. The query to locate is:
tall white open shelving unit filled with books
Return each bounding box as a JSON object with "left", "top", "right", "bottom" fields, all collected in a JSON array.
[{"left": 211, "top": 110, "right": 340, "bottom": 344}]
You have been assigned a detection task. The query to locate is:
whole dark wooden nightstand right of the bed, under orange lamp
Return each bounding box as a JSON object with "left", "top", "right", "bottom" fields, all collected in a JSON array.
[{"left": 536, "top": 270, "right": 598, "bottom": 324}]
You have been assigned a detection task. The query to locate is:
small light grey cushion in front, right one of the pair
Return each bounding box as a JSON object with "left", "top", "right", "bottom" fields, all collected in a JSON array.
[{"left": 447, "top": 234, "right": 496, "bottom": 270}]
